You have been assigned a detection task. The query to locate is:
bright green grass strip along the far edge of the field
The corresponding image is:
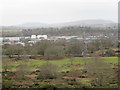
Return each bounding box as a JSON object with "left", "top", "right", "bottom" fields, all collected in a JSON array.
[{"left": 2, "top": 57, "right": 118, "bottom": 72}]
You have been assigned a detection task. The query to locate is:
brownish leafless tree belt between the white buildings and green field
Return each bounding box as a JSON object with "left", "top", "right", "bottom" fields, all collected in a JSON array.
[{"left": 3, "top": 39, "right": 117, "bottom": 57}]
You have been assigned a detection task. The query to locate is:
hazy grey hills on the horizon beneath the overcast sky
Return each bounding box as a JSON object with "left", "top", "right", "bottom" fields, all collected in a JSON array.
[{"left": 2, "top": 19, "right": 117, "bottom": 30}]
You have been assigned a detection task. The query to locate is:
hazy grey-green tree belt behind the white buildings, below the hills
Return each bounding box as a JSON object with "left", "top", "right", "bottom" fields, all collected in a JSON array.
[{"left": 22, "top": 26, "right": 117, "bottom": 36}]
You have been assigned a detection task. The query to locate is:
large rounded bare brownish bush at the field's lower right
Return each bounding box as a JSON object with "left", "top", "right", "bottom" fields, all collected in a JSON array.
[{"left": 85, "top": 57, "right": 115, "bottom": 87}]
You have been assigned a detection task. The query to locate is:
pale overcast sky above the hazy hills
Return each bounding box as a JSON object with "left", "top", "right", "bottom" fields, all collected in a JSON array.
[{"left": 0, "top": 0, "right": 119, "bottom": 26}]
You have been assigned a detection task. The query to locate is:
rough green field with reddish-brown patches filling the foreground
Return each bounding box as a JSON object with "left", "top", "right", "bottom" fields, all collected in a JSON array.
[{"left": 3, "top": 57, "right": 118, "bottom": 88}]
